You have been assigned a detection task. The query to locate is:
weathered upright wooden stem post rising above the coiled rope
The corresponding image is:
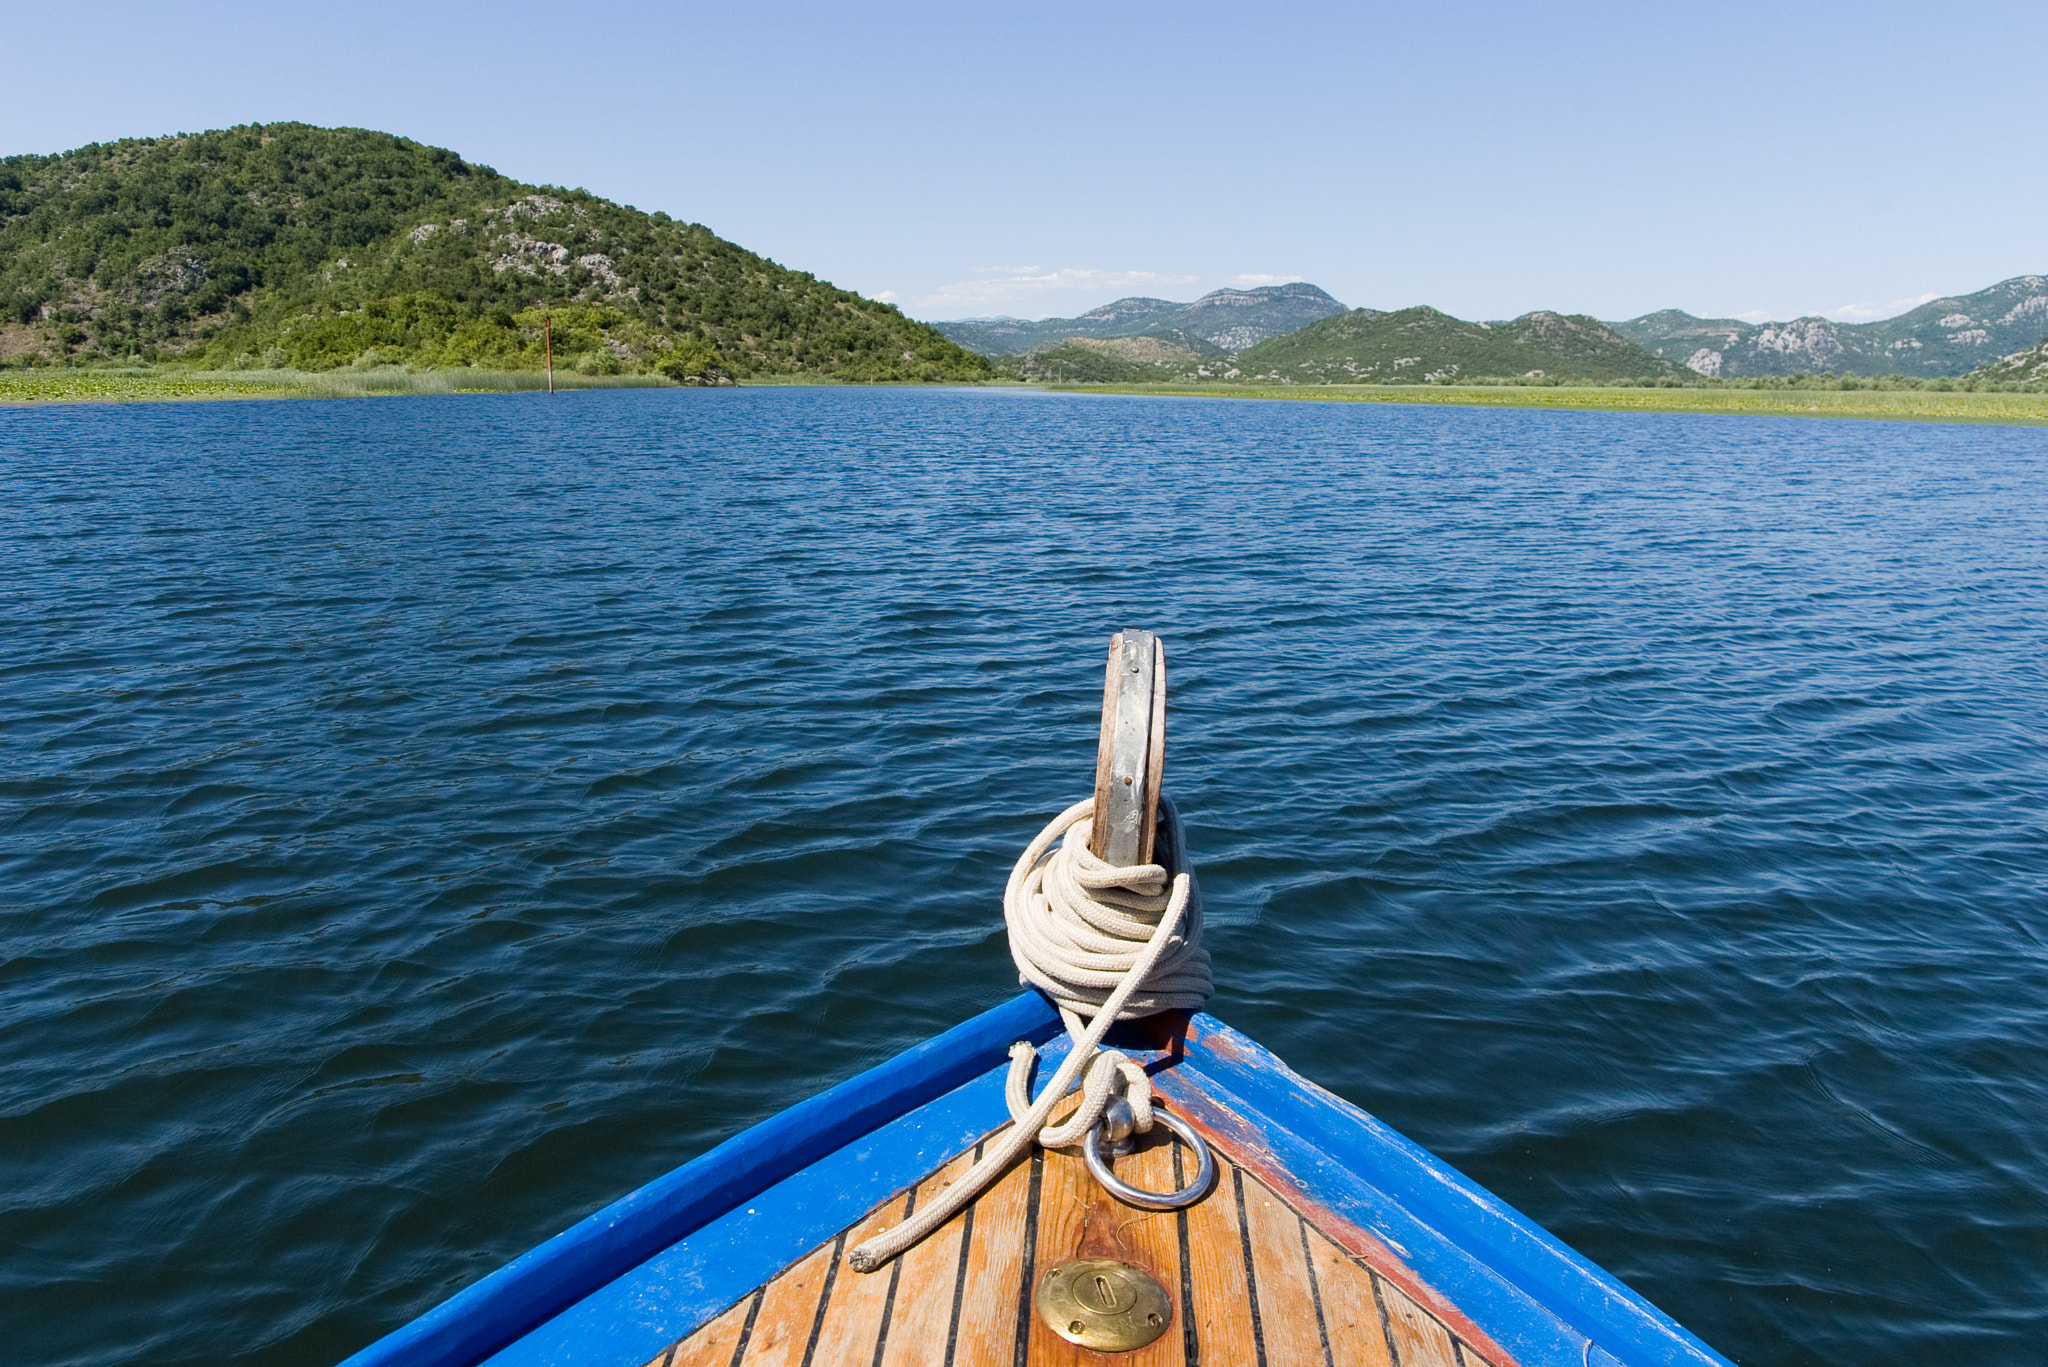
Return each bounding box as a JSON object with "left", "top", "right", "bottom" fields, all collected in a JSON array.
[{"left": 1087, "top": 629, "right": 1165, "bottom": 867}]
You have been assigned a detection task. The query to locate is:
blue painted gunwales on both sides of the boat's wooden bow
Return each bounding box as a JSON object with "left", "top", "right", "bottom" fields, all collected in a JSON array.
[{"left": 346, "top": 994, "right": 1726, "bottom": 1367}]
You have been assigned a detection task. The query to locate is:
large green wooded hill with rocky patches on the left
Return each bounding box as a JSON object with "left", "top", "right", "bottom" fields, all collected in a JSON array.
[{"left": 0, "top": 123, "right": 993, "bottom": 379}]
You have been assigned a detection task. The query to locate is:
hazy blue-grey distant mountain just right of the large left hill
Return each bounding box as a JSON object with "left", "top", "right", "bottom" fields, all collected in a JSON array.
[{"left": 932, "top": 283, "right": 1343, "bottom": 357}]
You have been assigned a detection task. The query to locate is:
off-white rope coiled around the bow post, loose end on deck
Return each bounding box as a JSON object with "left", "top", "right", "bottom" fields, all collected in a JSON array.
[{"left": 848, "top": 795, "right": 1210, "bottom": 1273}]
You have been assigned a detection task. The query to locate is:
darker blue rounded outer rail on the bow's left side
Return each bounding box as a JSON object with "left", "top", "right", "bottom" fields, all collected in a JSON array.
[{"left": 342, "top": 992, "right": 1059, "bottom": 1367}]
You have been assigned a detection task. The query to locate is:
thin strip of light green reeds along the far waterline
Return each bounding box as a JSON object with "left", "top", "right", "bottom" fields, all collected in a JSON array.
[{"left": 0, "top": 365, "right": 2048, "bottom": 426}]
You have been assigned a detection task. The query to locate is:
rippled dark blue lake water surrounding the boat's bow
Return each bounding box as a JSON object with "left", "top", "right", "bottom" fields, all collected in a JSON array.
[{"left": 0, "top": 389, "right": 2048, "bottom": 1367}]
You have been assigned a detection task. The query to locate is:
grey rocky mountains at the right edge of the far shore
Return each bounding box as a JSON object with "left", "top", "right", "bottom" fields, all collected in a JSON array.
[{"left": 1612, "top": 275, "right": 2048, "bottom": 375}]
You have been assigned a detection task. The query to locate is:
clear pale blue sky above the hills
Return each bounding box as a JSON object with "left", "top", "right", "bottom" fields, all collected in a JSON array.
[{"left": 0, "top": 0, "right": 2048, "bottom": 320}]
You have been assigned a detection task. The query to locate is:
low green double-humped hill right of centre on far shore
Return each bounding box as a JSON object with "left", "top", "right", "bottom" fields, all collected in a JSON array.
[{"left": 1233, "top": 307, "right": 1683, "bottom": 383}]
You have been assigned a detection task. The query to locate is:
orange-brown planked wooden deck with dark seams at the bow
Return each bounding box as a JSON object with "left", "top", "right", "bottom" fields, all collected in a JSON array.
[{"left": 647, "top": 1129, "right": 1511, "bottom": 1367}]
